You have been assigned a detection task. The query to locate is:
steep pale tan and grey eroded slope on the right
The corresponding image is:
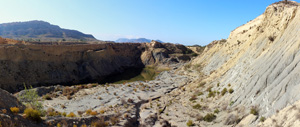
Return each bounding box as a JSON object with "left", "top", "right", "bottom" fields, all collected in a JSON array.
[{"left": 193, "top": 2, "right": 300, "bottom": 117}]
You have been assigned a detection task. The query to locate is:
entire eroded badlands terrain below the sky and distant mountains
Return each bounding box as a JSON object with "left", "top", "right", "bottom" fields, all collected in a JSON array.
[{"left": 0, "top": 1, "right": 300, "bottom": 127}]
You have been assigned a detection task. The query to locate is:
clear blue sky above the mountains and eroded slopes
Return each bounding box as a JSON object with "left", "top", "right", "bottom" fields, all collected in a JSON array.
[{"left": 0, "top": 0, "right": 299, "bottom": 45}]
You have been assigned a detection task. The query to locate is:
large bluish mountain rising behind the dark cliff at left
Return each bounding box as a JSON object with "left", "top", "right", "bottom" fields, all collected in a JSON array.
[{"left": 0, "top": 20, "right": 96, "bottom": 41}]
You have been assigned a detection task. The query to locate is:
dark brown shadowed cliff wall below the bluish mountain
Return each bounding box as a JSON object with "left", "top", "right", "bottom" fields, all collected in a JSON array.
[{"left": 0, "top": 42, "right": 190, "bottom": 92}]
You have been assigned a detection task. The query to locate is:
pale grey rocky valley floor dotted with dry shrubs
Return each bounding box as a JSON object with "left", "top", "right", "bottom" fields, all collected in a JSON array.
[{"left": 9, "top": 63, "right": 197, "bottom": 126}]
